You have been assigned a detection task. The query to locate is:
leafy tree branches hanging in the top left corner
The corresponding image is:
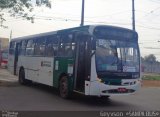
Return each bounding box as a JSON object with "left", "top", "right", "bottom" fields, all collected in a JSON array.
[{"left": 0, "top": 0, "right": 51, "bottom": 28}]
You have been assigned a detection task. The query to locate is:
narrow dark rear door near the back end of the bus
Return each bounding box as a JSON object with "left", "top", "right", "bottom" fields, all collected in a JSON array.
[{"left": 14, "top": 43, "right": 20, "bottom": 75}]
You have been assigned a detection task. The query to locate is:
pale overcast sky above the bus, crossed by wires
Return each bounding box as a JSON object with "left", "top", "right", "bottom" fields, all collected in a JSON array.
[{"left": 0, "top": 0, "right": 160, "bottom": 61}]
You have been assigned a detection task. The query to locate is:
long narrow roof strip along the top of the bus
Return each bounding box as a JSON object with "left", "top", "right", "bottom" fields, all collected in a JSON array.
[{"left": 11, "top": 25, "right": 136, "bottom": 41}]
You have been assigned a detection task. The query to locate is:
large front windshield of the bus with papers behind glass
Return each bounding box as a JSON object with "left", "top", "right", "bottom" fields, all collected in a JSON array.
[{"left": 96, "top": 39, "right": 140, "bottom": 72}]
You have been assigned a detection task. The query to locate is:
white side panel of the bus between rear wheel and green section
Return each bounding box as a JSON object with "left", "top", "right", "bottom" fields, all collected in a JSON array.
[{"left": 18, "top": 56, "right": 53, "bottom": 86}]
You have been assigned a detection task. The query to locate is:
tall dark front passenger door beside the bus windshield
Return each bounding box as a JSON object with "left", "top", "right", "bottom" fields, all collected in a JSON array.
[{"left": 74, "top": 34, "right": 91, "bottom": 92}]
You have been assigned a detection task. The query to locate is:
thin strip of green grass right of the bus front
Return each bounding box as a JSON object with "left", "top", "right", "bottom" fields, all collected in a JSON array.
[{"left": 142, "top": 74, "right": 160, "bottom": 80}]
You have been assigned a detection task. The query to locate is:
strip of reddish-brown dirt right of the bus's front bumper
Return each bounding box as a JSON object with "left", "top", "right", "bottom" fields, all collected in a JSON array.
[{"left": 142, "top": 80, "right": 160, "bottom": 87}]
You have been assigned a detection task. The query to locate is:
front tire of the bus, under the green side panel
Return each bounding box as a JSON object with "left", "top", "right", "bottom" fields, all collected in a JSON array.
[{"left": 59, "top": 76, "right": 70, "bottom": 99}]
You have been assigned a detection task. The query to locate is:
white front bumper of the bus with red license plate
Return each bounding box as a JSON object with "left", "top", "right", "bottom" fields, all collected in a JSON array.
[{"left": 85, "top": 79, "right": 141, "bottom": 97}]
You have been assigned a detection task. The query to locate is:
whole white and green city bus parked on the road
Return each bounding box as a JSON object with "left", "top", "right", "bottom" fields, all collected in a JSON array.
[{"left": 8, "top": 25, "right": 141, "bottom": 98}]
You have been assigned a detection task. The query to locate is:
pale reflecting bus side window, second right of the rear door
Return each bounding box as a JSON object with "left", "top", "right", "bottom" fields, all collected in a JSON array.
[{"left": 26, "top": 39, "right": 35, "bottom": 55}]
